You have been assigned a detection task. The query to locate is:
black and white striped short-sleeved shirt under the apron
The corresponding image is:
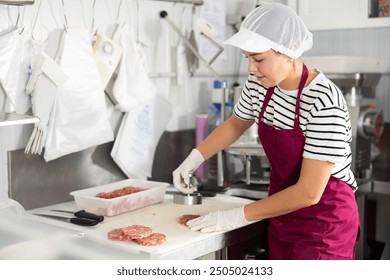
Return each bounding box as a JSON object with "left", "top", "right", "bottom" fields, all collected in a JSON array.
[{"left": 234, "top": 73, "right": 357, "bottom": 191}]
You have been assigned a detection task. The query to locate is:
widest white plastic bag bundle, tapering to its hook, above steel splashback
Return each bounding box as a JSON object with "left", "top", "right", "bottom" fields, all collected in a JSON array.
[{"left": 44, "top": 29, "right": 114, "bottom": 161}]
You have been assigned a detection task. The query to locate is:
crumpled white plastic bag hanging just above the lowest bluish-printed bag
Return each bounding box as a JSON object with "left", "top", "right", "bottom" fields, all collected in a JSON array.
[{"left": 112, "top": 27, "right": 156, "bottom": 112}]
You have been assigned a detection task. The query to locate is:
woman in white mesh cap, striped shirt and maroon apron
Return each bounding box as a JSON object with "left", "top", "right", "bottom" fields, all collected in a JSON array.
[{"left": 173, "top": 4, "right": 359, "bottom": 259}]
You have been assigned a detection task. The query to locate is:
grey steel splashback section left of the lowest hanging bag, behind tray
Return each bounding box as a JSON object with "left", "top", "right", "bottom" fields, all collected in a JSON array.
[{"left": 8, "top": 142, "right": 127, "bottom": 210}]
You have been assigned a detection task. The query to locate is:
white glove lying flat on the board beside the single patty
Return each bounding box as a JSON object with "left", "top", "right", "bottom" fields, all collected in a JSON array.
[{"left": 187, "top": 206, "right": 251, "bottom": 232}]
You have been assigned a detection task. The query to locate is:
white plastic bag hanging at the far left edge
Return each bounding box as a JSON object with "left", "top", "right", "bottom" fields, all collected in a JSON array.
[{"left": 0, "top": 27, "right": 24, "bottom": 112}]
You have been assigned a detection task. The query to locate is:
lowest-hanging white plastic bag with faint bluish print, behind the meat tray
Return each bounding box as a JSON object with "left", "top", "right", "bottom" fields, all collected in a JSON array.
[{"left": 111, "top": 94, "right": 172, "bottom": 180}]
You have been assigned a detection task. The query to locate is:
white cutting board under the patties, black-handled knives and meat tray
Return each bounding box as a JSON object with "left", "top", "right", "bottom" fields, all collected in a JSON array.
[{"left": 29, "top": 195, "right": 253, "bottom": 259}]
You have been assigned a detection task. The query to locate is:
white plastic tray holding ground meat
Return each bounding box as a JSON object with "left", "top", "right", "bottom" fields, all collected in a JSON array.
[{"left": 70, "top": 179, "right": 169, "bottom": 216}]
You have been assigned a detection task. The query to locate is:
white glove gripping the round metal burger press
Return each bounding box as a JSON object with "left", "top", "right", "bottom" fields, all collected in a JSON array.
[{"left": 172, "top": 149, "right": 204, "bottom": 193}]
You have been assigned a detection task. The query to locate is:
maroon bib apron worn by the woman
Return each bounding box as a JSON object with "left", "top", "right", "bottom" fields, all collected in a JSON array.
[{"left": 258, "top": 65, "right": 359, "bottom": 260}]
